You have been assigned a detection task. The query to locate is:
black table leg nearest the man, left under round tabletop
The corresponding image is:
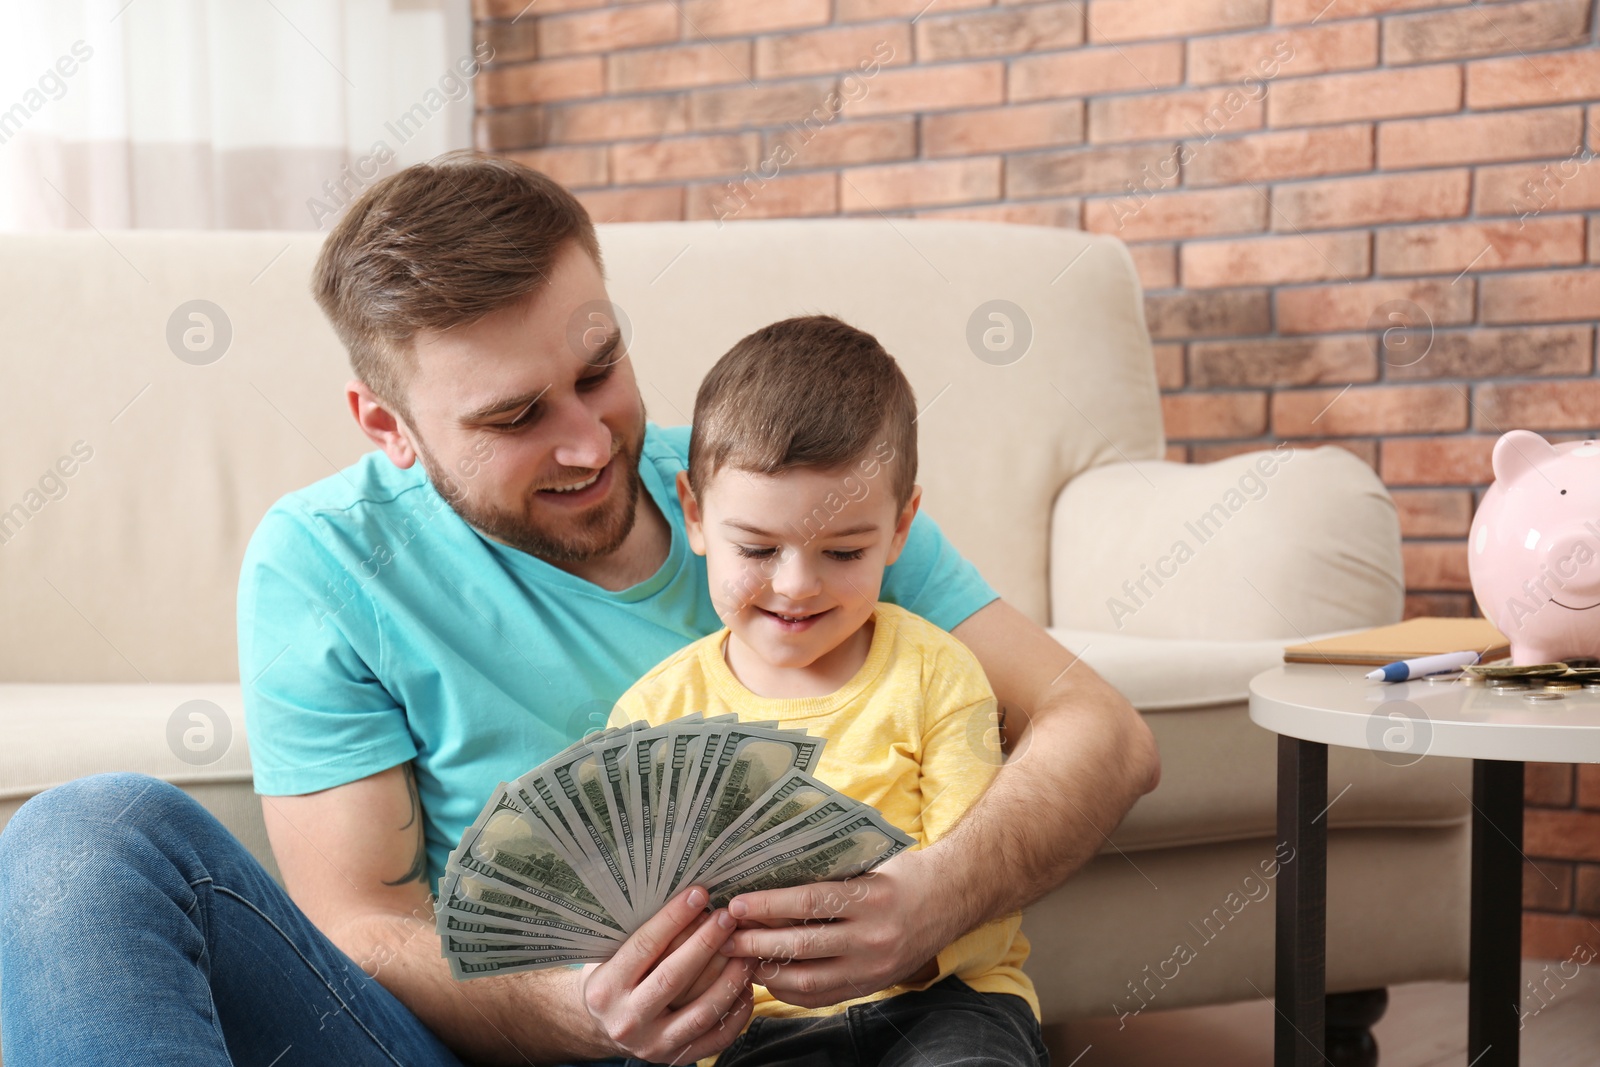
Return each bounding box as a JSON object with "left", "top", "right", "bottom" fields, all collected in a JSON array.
[{"left": 1274, "top": 734, "right": 1328, "bottom": 1067}]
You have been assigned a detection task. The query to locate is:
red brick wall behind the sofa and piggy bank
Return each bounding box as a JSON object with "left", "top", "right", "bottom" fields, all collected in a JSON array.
[{"left": 475, "top": 0, "right": 1600, "bottom": 957}]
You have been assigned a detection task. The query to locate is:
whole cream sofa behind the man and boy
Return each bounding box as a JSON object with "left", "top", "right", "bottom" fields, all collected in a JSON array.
[{"left": 0, "top": 219, "right": 1470, "bottom": 1049}]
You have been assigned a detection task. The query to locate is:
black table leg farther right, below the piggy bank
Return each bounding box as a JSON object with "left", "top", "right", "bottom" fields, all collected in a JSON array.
[{"left": 1467, "top": 760, "right": 1523, "bottom": 1067}]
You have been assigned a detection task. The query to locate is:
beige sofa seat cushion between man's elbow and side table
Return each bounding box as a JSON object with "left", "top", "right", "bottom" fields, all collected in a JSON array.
[{"left": 1050, "top": 629, "right": 1472, "bottom": 851}]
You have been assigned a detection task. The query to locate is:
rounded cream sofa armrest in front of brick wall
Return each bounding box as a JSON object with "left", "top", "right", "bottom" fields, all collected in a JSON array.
[{"left": 1050, "top": 445, "right": 1405, "bottom": 641}]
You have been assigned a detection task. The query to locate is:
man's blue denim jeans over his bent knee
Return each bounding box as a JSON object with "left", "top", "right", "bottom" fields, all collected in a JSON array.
[{"left": 0, "top": 774, "right": 611, "bottom": 1067}]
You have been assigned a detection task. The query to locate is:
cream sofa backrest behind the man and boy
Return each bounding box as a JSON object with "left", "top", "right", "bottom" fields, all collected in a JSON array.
[{"left": 0, "top": 219, "right": 1165, "bottom": 681}]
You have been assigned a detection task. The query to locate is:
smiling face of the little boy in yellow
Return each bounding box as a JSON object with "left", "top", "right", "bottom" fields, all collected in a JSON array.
[{"left": 678, "top": 466, "right": 922, "bottom": 667}]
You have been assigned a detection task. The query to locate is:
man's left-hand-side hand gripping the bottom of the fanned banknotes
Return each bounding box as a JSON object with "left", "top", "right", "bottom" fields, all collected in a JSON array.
[{"left": 584, "top": 886, "right": 754, "bottom": 1064}]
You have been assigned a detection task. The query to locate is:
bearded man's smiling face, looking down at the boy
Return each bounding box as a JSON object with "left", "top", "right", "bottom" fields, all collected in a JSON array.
[{"left": 396, "top": 242, "right": 645, "bottom": 563}]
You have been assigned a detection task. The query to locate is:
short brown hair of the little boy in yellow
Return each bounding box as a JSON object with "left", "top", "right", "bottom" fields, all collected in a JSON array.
[{"left": 688, "top": 315, "right": 917, "bottom": 510}]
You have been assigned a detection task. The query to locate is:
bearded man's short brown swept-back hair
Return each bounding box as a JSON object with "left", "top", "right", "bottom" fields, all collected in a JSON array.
[{"left": 312, "top": 152, "right": 600, "bottom": 414}]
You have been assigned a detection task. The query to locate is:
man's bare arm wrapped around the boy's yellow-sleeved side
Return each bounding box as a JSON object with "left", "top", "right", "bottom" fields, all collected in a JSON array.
[{"left": 723, "top": 600, "right": 1160, "bottom": 1006}]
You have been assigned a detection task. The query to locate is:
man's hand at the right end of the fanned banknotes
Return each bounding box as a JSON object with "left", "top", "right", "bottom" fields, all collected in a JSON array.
[{"left": 710, "top": 851, "right": 934, "bottom": 1008}]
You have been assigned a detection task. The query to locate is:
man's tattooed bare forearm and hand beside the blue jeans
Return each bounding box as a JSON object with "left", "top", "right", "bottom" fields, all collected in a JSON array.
[{"left": 261, "top": 763, "right": 750, "bottom": 1064}]
